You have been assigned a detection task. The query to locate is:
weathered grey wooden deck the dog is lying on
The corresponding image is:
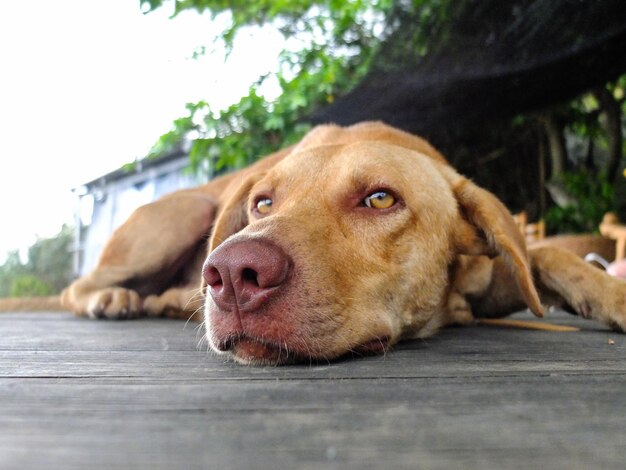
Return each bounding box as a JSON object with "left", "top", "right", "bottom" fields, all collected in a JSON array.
[{"left": 0, "top": 313, "right": 626, "bottom": 470}]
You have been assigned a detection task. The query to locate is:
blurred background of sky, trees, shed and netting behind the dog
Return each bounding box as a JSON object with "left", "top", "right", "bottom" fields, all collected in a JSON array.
[{"left": 0, "top": 0, "right": 626, "bottom": 296}]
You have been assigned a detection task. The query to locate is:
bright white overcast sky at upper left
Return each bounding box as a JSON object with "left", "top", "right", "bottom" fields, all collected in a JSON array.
[{"left": 0, "top": 0, "right": 281, "bottom": 261}]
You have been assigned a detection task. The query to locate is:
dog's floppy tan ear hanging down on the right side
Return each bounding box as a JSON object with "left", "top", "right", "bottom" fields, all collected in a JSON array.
[{"left": 445, "top": 168, "right": 543, "bottom": 317}]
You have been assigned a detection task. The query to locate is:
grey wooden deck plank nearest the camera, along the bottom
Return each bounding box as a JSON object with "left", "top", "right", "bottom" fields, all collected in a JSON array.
[{"left": 0, "top": 377, "right": 626, "bottom": 468}]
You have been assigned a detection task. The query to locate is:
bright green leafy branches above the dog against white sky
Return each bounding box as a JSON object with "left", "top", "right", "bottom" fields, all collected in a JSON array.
[{"left": 142, "top": 0, "right": 400, "bottom": 170}]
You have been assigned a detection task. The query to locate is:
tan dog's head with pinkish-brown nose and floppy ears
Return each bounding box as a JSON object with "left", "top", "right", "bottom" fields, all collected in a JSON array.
[{"left": 203, "top": 124, "right": 541, "bottom": 364}]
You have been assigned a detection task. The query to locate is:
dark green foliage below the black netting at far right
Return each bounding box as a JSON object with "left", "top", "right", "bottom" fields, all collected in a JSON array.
[{"left": 542, "top": 75, "right": 626, "bottom": 233}]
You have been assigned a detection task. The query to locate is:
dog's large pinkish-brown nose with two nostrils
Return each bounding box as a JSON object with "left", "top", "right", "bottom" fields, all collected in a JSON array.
[{"left": 203, "top": 240, "right": 292, "bottom": 312}]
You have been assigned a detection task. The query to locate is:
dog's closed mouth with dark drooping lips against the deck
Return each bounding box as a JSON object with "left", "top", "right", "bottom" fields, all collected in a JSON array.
[{"left": 216, "top": 334, "right": 390, "bottom": 366}]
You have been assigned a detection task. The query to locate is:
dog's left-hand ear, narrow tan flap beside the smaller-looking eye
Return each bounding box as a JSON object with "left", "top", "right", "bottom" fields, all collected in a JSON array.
[{"left": 209, "top": 172, "right": 265, "bottom": 252}]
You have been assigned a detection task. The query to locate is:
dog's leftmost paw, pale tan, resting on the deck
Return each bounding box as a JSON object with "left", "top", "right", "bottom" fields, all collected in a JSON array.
[{"left": 87, "top": 287, "right": 143, "bottom": 320}]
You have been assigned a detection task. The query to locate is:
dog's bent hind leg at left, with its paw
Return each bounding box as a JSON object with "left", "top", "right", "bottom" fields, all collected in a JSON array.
[{"left": 61, "top": 191, "right": 216, "bottom": 318}]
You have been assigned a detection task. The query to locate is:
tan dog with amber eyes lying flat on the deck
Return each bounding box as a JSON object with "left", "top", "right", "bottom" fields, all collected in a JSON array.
[{"left": 62, "top": 123, "right": 626, "bottom": 364}]
